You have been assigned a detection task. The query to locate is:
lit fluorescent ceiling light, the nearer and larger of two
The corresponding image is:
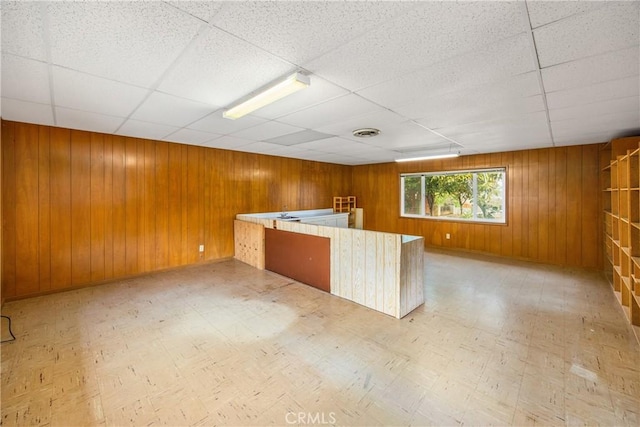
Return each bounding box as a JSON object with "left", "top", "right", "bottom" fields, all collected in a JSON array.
[{"left": 222, "top": 73, "right": 310, "bottom": 120}]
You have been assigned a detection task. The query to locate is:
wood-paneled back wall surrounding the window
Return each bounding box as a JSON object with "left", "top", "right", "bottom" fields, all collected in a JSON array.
[{"left": 351, "top": 144, "right": 603, "bottom": 268}]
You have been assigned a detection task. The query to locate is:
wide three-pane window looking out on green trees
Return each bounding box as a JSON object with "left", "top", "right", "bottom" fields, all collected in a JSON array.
[{"left": 400, "top": 168, "right": 507, "bottom": 223}]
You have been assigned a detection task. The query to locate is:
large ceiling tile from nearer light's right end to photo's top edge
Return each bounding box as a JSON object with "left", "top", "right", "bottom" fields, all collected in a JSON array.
[{"left": 303, "top": 2, "right": 525, "bottom": 90}]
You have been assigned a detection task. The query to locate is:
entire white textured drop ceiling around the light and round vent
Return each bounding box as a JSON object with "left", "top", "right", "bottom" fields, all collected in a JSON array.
[{"left": 0, "top": 1, "right": 640, "bottom": 165}]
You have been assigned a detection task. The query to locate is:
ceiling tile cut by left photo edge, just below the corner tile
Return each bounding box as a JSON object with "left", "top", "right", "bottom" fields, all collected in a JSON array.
[{"left": 2, "top": 55, "right": 51, "bottom": 104}]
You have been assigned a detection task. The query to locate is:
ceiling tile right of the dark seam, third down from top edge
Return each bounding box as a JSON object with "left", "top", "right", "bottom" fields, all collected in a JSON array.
[{"left": 542, "top": 47, "right": 640, "bottom": 92}]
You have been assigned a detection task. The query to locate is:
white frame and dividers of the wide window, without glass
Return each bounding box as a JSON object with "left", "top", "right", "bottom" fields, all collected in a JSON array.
[{"left": 400, "top": 166, "right": 509, "bottom": 225}]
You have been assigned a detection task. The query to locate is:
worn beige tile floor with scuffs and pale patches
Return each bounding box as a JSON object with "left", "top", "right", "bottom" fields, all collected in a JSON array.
[{"left": 1, "top": 251, "right": 640, "bottom": 426}]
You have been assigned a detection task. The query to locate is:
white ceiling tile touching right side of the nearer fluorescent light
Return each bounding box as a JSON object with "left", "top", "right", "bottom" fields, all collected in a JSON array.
[{"left": 254, "top": 75, "right": 349, "bottom": 120}]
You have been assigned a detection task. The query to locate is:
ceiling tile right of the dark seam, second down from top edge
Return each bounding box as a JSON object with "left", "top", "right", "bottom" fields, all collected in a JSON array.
[{"left": 534, "top": 2, "right": 640, "bottom": 68}]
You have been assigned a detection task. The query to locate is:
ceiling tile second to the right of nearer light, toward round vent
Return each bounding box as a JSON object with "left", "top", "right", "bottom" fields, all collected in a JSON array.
[{"left": 278, "top": 94, "right": 383, "bottom": 128}]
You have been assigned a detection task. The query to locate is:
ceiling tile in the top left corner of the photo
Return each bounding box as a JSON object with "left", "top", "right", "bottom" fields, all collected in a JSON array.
[{"left": 0, "top": 1, "right": 47, "bottom": 61}]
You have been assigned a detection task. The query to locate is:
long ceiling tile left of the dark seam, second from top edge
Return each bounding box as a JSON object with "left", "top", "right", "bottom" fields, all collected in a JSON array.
[{"left": 358, "top": 34, "right": 536, "bottom": 108}]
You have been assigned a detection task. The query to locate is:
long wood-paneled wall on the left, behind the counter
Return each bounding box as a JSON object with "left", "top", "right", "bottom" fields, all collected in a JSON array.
[{"left": 2, "top": 121, "right": 351, "bottom": 298}]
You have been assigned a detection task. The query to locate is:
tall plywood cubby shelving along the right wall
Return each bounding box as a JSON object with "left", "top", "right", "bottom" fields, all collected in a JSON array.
[{"left": 601, "top": 137, "right": 640, "bottom": 340}]
